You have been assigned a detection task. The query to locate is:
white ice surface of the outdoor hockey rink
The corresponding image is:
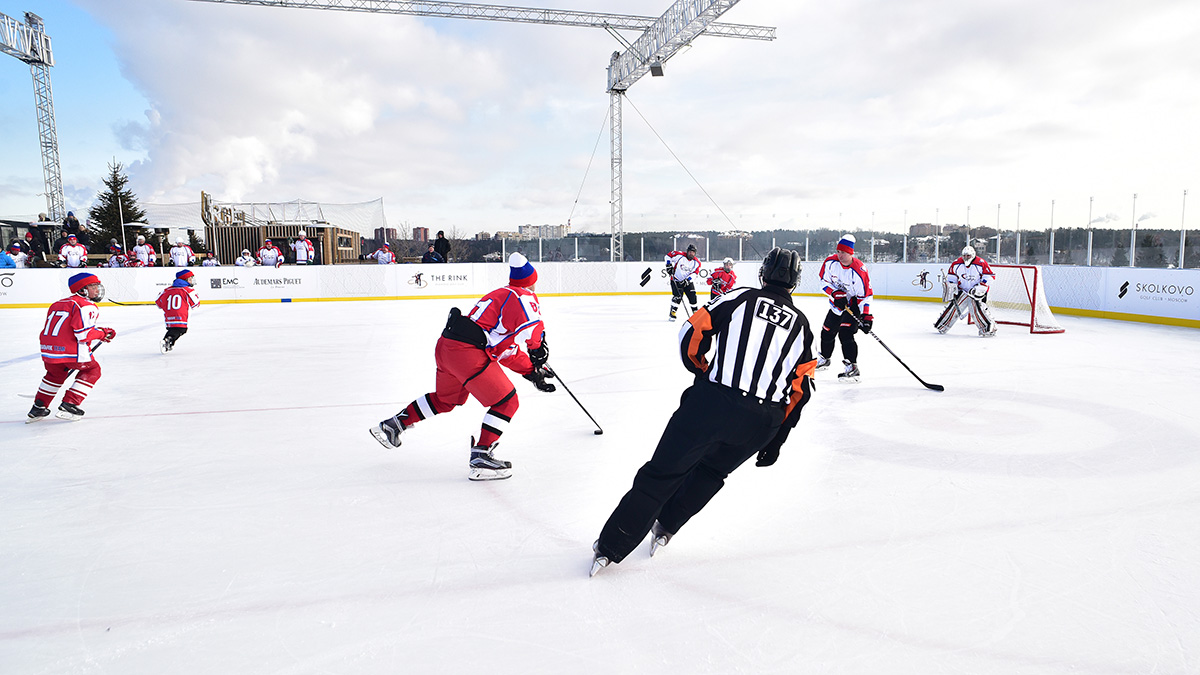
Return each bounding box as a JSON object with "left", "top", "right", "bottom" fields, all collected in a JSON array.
[{"left": 0, "top": 289, "right": 1200, "bottom": 675}]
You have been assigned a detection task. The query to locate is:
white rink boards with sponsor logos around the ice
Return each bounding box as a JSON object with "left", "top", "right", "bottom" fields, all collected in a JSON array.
[{"left": 0, "top": 262, "right": 1200, "bottom": 328}]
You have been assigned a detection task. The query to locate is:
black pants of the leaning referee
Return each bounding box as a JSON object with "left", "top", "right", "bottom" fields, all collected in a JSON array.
[{"left": 596, "top": 380, "right": 784, "bottom": 562}]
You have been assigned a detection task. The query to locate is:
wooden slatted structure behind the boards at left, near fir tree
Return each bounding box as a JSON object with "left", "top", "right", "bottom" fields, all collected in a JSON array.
[{"left": 200, "top": 192, "right": 362, "bottom": 264}]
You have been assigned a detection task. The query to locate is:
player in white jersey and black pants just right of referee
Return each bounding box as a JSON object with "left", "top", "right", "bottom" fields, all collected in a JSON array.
[{"left": 817, "top": 234, "right": 875, "bottom": 382}]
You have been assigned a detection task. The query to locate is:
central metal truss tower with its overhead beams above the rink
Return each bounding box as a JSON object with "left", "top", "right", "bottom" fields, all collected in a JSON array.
[{"left": 187, "top": 0, "right": 775, "bottom": 261}]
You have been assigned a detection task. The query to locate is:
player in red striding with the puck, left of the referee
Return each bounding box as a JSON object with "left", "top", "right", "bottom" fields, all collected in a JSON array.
[{"left": 371, "top": 253, "right": 554, "bottom": 480}]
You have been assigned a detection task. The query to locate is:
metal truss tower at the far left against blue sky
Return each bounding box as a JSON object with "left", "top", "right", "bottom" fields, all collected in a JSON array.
[{"left": 0, "top": 12, "right": 66, "bottom": 221}]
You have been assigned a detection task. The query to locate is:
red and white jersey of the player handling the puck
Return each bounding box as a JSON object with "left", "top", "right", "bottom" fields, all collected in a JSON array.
[{"left": 468, "top": 281, "right": 545, "bottom": 375}]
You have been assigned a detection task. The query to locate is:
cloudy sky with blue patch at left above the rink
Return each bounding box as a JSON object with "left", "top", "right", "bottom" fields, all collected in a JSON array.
[{"left": 0, "top": 0, "right": 1200, "bottom": 235}]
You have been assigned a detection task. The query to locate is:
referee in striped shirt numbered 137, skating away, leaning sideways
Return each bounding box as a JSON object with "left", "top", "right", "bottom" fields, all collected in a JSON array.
[{"left": 592, "top": 249, "right": 816, "bottom": 575}]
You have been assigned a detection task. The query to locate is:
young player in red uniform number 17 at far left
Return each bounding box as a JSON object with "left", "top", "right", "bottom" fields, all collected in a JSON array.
[{"left": 25, "top": 273, "right": 116, "bottom": 424}]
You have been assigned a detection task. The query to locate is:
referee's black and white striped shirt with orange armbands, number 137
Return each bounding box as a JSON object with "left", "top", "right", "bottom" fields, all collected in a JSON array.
[{"left": 679, "top": 285, "right": 816, "bottom": 408}]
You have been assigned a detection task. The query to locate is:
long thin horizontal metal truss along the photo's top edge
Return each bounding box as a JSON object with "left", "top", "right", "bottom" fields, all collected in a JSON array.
[{"left": 183, "top": 0, "right": 775, "bottom": 40}]
